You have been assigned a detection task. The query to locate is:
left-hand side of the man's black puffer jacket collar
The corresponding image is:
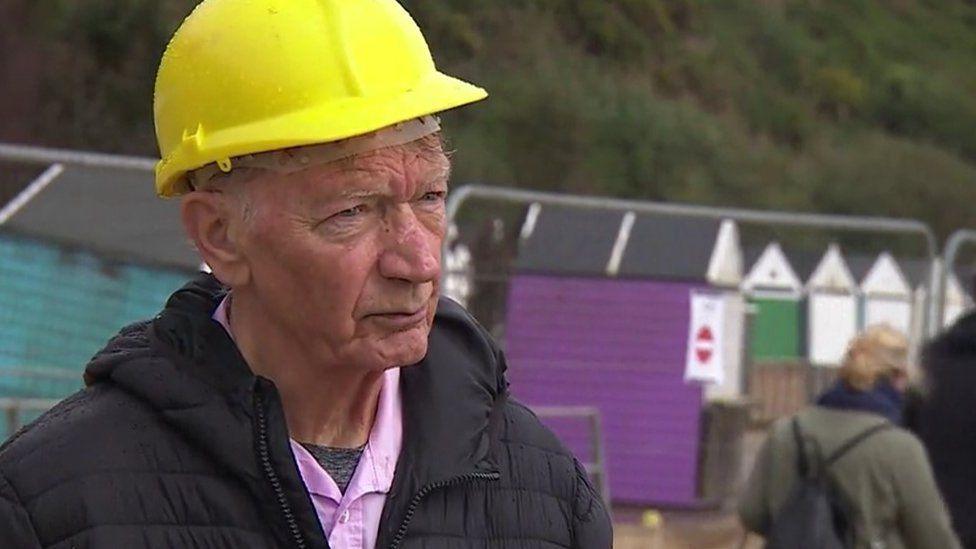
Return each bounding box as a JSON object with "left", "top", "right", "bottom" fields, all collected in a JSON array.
[{"left": 85, "top": 276, "right": 260, "bottom": 492}]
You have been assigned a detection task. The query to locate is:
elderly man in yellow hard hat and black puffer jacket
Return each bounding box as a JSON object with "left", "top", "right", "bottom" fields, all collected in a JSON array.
[{"left": 0, "top": 0, "right": 611, "bottom": 549}]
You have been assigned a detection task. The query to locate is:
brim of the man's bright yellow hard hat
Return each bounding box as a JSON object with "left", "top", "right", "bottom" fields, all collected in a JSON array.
[{"left": 156, "top": 72, "right": 488, "bottom": 198}]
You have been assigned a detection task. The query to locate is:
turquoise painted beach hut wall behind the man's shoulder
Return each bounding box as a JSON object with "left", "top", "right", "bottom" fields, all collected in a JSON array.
[{"left": 0, "top": 235, "right": 192, "bottom": 398}]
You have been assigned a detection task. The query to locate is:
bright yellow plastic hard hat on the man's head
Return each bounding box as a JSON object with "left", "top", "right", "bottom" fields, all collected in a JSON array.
[{"left": 154, "top": 0, "right": 488, "bottom": 197}]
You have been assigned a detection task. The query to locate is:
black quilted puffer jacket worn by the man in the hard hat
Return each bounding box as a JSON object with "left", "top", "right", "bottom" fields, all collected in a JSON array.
[{"left": 0, "top": 277, "right": 611, "bottom": 549}]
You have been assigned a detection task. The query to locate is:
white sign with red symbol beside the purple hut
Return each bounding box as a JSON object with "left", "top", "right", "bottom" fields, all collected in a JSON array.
[{"left": 685, "top": 292, "right": 725, "bottom": 384}]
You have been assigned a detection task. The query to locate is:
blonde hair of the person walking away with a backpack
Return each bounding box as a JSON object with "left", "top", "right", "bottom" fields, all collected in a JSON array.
[{"left": 838, "top": 324, "right": 908, "bottom": 391}]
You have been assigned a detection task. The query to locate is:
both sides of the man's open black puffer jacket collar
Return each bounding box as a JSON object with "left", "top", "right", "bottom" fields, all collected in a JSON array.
[{"left": 85, "top": 275, "right": 507, "bottom": 538}]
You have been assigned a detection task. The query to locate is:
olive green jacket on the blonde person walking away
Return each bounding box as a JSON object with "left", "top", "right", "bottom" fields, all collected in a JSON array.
[{"left": 739, "top": 406, "right": 959, "bottom": 549}]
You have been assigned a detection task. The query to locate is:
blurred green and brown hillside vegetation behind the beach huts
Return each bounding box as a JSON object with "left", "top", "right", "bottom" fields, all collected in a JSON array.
[{"left": 0, "top": 0, "right": 976, "bottom": 238}]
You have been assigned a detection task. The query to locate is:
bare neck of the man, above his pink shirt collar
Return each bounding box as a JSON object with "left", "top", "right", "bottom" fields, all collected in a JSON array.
[{"left": 227, "top": 296, "right": 383, "bottom": 448}]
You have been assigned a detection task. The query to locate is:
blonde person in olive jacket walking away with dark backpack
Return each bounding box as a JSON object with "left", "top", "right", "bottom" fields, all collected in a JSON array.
[{"left": 739, "top": 326, "right": 959, "bottom": 549}]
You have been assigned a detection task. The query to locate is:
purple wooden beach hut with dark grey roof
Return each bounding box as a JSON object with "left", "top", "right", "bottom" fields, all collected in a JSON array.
[{"left": 506, "top": 206, "right": 742, "bottom": 507}]
